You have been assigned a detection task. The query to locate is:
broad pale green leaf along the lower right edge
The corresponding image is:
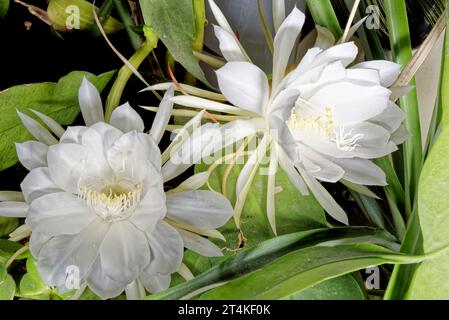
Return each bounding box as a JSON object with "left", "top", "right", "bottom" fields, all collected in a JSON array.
[{"left": 407, "top": 128, "right": 449, "bottom": 300}]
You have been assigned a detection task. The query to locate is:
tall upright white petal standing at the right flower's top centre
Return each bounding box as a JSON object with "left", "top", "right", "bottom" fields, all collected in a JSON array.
[{"left": 272, "top": 7, "right": 306, "bottom": 90}]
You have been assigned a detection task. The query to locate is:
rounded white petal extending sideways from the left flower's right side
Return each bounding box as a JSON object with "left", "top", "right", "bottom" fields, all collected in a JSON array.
[{"left": 167, "top": 190, "right": 233, "bottom": 229}]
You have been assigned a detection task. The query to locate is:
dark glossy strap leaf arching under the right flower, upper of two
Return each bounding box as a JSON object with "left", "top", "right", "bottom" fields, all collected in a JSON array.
[{"left": 148, "top": 227, "right": 400, "bottom": 299}]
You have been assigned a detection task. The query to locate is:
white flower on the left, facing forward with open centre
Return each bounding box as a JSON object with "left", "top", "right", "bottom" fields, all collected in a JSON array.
[{"left": 0, "top": 79, "right": 233, "bottom": 298}]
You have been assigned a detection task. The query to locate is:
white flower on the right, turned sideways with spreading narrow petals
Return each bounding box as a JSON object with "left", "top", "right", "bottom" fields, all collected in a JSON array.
[{"left": 150, "top": 0, "right": 407, "bottom": 232}]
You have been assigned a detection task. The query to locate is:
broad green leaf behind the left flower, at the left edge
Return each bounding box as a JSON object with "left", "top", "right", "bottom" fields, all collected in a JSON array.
[{"left": 0, "top": 71, "right": 115, "bottom": 170}]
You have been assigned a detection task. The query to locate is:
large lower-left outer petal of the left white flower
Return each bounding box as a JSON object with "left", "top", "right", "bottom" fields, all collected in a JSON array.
[{"left": 33, "top": 218, "right": 109, "bottom": 286}]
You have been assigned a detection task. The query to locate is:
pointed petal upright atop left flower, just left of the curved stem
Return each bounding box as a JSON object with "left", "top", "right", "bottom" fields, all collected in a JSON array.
[{"left": 78, "top": 77, "right": 104, "bottom": 126}]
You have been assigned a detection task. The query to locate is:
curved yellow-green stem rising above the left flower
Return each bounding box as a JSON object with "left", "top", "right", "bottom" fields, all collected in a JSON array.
[{"left": 105, "top": 31, "right": 158, "bottom": 122}]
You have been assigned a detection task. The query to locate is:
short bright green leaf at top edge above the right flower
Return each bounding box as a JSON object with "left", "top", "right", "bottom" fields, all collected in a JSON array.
[{"left": 307, "top": 0, "right": 343, "bottom": 39}]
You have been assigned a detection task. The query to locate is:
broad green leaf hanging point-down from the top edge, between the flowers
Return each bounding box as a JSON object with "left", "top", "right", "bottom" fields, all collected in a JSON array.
[{"left": 139, "top": 0, "right": 209, "bottom": 84}]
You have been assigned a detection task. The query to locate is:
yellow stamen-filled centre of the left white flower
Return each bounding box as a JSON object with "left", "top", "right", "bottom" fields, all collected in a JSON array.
[{"left": 78, "top": 183, "right": 142, "bottom": 222}]
